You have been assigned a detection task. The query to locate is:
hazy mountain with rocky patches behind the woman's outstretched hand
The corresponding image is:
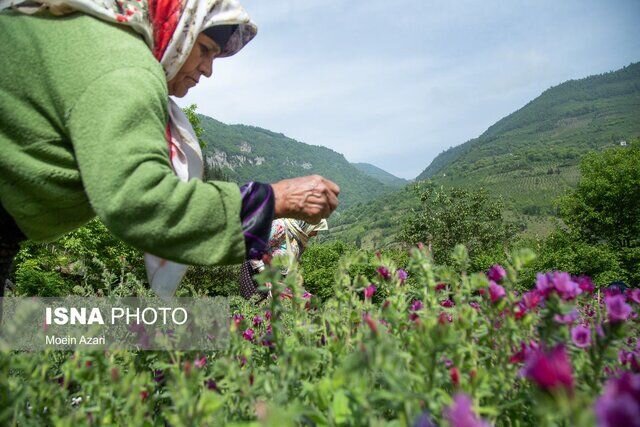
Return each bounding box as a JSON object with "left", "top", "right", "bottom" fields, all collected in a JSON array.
[{"left": 198, "top": 115, "right": 393, "bottom": 210}]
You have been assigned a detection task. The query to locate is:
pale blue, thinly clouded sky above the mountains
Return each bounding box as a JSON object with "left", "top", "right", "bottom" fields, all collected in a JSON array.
[{"left": 177, "top": 0, "right": 640, "bottom": 179}]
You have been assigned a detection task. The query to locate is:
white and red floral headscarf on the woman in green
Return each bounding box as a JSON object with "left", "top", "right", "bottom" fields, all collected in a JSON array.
[{"left": 0, "top": 0, "right": 258, "bottom": 297}]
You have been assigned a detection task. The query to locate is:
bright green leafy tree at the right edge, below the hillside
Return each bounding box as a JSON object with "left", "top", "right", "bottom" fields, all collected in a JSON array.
[{"left": 560, "top": 140, "right": 640, "bottom": 249}]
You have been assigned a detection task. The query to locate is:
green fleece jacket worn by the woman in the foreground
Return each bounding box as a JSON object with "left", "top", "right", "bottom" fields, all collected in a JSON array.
[{"left": 0, "top": 12, "right": 245, "bottom": 265}]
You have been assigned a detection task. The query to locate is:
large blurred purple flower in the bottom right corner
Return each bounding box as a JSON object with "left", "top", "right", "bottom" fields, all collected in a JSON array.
[{"left": 594, "top": 372, "right": 640, "bottom": 427}]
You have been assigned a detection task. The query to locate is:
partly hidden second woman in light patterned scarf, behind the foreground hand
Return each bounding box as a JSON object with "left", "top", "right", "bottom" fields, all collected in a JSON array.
[{"left": 240, "top": 218, "right": 329, "bottom": 299}]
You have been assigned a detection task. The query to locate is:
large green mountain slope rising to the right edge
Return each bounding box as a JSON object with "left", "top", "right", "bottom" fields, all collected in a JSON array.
[{"left": 416, "top": 63, "right": 640, "bottom": 215}]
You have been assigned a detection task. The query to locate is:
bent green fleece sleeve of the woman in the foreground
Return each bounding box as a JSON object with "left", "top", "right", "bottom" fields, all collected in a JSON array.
[{"left": 67, "top": 68, "right": 245, "bottom": 265}]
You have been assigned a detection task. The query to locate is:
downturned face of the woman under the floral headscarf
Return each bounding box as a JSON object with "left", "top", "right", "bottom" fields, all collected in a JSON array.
[{"left": 167, "top": 33, "right": 220, "bottom": 98}]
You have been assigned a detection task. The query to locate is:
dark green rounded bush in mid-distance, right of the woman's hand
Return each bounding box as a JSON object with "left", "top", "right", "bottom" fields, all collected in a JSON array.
[{"left": 401, "top": 182, "right": 515, "bottom": 268}]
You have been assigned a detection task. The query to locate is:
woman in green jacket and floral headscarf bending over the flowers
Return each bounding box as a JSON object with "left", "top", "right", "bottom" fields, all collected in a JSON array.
[{"left": 0, "top": 0, "right": 339, "bottom": 302}]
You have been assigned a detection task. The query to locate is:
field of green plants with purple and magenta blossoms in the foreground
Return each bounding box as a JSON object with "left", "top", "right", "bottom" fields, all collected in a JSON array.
[{"left": 0, "top": 247, "right": 640, "bottom": 426}]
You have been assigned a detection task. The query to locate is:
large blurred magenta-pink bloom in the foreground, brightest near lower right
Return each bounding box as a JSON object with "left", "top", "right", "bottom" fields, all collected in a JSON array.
[{"left": 521, "top": 345, "right": 573, "bottom": 392}]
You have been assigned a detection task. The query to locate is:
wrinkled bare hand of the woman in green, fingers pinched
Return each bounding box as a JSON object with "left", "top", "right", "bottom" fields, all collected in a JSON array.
[{"left": 271, "top": 175, "right": 340, "bottom": 224}]
